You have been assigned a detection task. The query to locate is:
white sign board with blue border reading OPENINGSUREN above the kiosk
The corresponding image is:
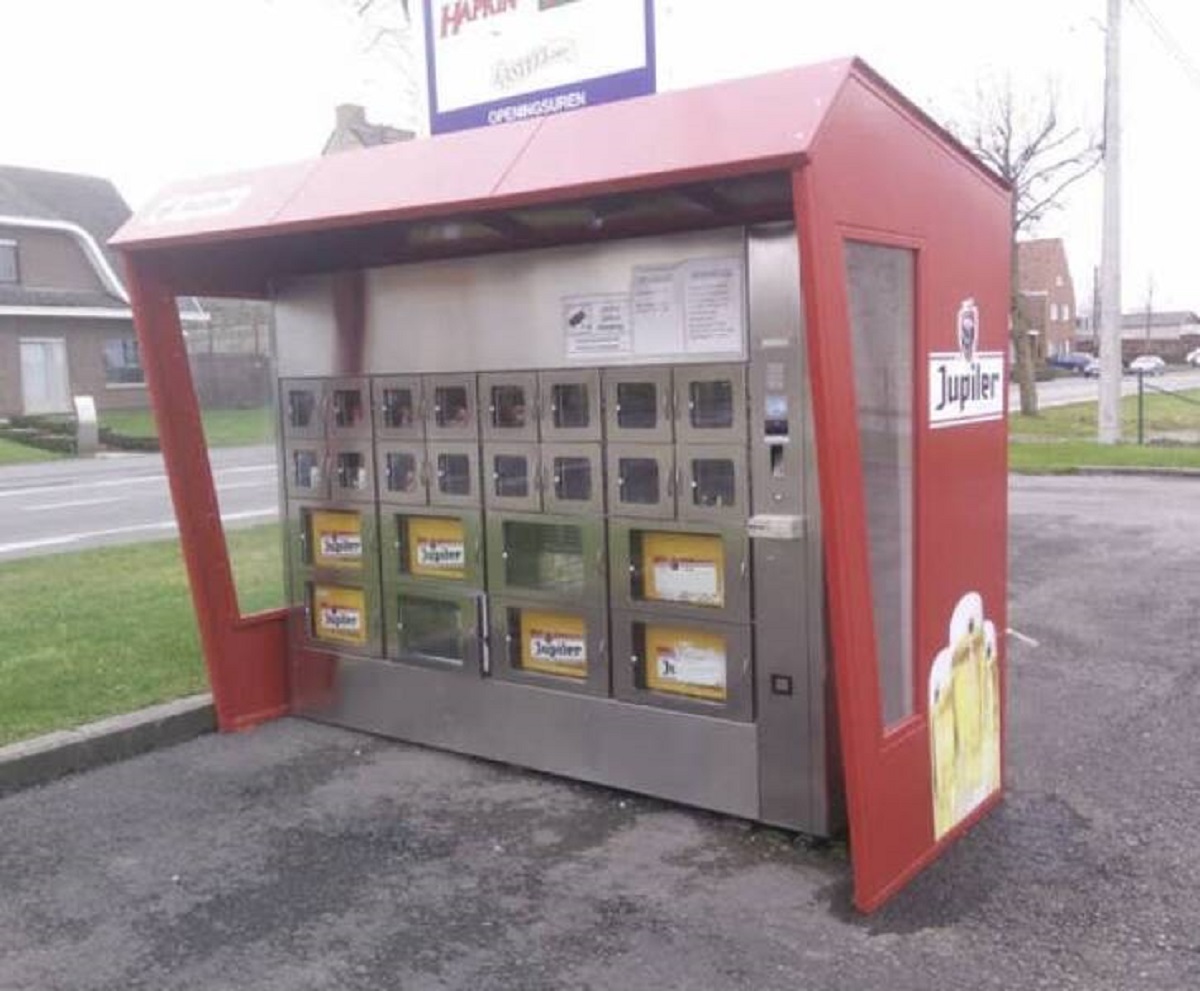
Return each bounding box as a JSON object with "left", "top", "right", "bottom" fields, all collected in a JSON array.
[{"left": 424, "top": 0, "right": 654, "bottom": 134}]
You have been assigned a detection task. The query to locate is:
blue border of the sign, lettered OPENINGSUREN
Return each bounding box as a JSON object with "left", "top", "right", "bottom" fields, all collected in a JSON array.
[{"left": 422, "top": 0, "right": 658, "bottom": 134}]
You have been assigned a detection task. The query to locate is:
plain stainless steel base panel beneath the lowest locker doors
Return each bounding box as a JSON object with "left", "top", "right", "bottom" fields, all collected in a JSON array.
[{"left": 300, "top": 657, "right": 758, "bottom": 819}]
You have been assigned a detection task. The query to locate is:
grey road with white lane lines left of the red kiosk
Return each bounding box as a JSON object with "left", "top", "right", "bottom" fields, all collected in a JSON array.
[{"left": 0, "top": 446, "right": 280, "bottom": 563}]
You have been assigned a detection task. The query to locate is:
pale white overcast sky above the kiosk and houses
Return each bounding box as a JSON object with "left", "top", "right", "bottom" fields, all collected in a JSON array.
[{"left": 0, "top": 0, "right": 1200, "bottom": 310}]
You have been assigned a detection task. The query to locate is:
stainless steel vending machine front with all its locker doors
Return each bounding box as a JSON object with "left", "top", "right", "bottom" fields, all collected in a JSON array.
[{"left": 276, "top": 224, "right": 841, "bottom": 835}]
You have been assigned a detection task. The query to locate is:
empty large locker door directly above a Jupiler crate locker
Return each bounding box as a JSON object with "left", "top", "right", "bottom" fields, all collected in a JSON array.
[{"left": 486, "top": 513, "right": 607, "bottom": 607}]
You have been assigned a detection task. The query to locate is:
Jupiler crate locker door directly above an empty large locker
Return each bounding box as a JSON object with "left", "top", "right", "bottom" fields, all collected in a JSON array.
[{"left": 383, "top": 509, "right": 484, "bottom": 588}]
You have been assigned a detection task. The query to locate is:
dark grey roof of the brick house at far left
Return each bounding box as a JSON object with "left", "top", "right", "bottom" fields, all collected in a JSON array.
[{"left": 0, "top": 166, "right": 132, "bottom": 272}]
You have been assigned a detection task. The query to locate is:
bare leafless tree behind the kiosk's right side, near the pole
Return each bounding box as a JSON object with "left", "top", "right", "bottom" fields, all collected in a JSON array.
[{"left": 950, "top": 79, "right": 1102, "bottom": 415}]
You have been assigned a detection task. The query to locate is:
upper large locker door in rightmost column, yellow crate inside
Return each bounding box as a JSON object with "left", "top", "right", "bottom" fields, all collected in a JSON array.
[{"left": 608, "top": 519, "right": 750, "bottom": 623}]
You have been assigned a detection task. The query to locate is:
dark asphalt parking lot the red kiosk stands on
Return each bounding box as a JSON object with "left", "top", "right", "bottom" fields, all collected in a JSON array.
[{"left": 0, "top": 478, "right": 1200, "bottom": 991}]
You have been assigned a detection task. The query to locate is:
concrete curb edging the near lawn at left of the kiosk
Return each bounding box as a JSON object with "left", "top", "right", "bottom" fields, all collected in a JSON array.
[{"left": 0, "top": 695, "right": 216, "bottom": 795}]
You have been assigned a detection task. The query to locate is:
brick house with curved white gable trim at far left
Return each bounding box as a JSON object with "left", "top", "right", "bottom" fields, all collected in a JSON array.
[{"left": 0, "top": 166, "right": 204, "bottom": 416}]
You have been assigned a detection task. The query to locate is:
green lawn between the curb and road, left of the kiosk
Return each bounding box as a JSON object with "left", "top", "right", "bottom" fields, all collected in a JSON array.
[{"left": 0, "top": 523, "right": 283, "bottom": 744}]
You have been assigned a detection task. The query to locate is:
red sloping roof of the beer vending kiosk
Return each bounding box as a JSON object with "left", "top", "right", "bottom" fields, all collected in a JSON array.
[{"left": 114, "top": 59, "right": 1008, "bottom": 263}]
